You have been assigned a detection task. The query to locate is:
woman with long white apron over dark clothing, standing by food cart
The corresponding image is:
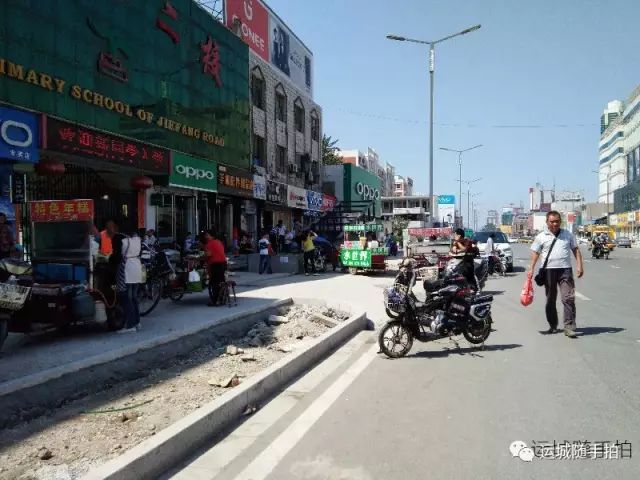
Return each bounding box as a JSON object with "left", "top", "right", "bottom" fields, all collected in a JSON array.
[{"left": 114, "top": 224, "right": 142, "bottom": 333}]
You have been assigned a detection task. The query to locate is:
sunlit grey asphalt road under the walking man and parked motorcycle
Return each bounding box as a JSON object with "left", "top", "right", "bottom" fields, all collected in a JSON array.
[{"left": 173, "top": 245, "right": 640, "bottom": 480}]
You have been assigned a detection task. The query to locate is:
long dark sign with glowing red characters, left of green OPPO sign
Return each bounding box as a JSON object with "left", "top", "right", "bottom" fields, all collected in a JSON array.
[{"left": 43, "top": 118, "right": 171, "bottom": 175}]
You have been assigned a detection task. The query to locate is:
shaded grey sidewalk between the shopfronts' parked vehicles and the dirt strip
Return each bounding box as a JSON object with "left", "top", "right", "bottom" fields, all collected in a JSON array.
[{"left": 0, "top": 272, "right": 289, "bottom": 395}]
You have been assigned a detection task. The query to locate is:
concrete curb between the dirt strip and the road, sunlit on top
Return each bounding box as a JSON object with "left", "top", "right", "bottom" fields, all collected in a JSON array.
[{"left": 83, "top": 312, "right": 367, "bottom": 480}]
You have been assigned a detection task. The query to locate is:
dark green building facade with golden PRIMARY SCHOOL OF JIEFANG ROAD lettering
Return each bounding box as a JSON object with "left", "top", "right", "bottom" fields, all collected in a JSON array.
[{"left": 0, "top": 0, "right": 250, "bottom": 251}]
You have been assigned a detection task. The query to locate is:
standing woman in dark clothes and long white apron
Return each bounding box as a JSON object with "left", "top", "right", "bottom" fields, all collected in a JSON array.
[{"left": 110, "top": 226, "right": 142, "bottom": 333}]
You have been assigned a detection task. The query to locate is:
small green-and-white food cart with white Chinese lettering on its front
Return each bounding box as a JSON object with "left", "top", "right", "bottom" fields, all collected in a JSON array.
[{"left": 340, "top": 223, "right": 389, "bottom": 275}]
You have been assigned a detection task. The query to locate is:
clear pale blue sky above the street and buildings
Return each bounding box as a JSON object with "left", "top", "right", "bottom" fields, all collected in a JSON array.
[{"left": 267, "top": 0, "right": 640, "bottom": 221}]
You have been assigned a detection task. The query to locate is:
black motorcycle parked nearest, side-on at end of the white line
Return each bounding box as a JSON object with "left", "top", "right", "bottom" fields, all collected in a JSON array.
[{"left": 378, "top": 274, "right": 493, "bottom": 358}]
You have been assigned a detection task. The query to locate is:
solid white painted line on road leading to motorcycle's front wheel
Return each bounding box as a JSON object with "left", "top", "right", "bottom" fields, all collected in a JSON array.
[{"left": 235, "top": 343, "right": 379, "bottom": 480}]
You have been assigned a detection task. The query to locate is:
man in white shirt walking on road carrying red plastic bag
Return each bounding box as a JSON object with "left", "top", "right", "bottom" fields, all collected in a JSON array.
[{"left": 529, "top": 210, "right": 584, "bottom": 338}]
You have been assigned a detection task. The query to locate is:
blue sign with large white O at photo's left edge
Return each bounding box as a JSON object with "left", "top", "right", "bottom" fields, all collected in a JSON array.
[{"left": 0, "top": 107, "right": 40, "bottom": 163}]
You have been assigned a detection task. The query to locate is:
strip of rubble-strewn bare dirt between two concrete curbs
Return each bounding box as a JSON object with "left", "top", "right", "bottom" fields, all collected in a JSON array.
[{"left": 0, "top": 305, "right": 348, "bottom": 480}]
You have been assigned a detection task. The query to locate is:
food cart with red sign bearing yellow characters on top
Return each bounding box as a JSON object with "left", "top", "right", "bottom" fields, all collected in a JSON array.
[{"left": 9, "top": 199, "right": 123, "bottom": 333}]
